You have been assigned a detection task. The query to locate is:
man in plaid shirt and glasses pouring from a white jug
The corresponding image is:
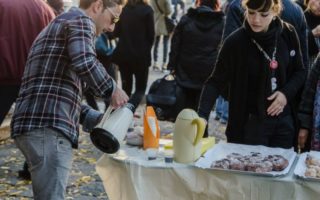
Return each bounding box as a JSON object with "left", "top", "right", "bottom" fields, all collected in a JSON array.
[{"left": 11, "top": 0, "right": 128, "bottom": 200}]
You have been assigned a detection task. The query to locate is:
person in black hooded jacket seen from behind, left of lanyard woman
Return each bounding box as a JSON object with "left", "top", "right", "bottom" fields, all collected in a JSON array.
[{"left": 168, "top": 0, "right": 224, "bottom": 116}]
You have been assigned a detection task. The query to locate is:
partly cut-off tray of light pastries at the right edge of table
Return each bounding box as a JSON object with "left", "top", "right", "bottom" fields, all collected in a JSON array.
[{"left": 293, "top": 151, "right": 320, "bottom": 181}]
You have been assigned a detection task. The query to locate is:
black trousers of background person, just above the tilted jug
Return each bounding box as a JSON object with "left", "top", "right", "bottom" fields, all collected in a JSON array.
[{"left": 119, "top": 66, "right": 149, "bottom": 108}]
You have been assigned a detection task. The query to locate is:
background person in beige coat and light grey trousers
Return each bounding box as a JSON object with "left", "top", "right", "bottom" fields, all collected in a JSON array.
[{"left": 150, "top": 0, "right": 172, "bottom": 71}]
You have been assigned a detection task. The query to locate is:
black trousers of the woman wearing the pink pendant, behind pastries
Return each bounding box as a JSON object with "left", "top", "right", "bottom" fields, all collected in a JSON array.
[{"left": 244, "top": 114, "right": 295, "bottom": 149}]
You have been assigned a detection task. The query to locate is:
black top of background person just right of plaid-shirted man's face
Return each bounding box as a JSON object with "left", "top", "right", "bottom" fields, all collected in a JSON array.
[{"left": 112, "top": 3, "right": 155, "bottom": 69}]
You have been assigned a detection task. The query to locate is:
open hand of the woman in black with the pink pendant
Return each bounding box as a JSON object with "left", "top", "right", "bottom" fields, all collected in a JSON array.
[{"left": 267, "top": 91, "right": 287, "bottom": 116}]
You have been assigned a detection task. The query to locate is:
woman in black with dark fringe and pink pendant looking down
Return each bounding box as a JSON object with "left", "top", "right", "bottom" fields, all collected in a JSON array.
[{"left": 198, "top": 0, "right": 306, "bottom": 148}]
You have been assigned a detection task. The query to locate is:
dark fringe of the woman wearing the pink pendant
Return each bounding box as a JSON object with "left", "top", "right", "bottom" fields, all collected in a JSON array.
[{"left": 242, "top": 0, "right": 282, "bottom": 14}]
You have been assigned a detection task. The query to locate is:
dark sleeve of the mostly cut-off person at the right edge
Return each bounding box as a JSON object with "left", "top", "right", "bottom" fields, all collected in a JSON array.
[{"left": 298, "top": 55, "right": 320, "bottom": 130}]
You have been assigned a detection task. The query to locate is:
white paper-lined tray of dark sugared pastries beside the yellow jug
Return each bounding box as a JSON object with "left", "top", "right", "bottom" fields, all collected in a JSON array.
[{"left": 196, "top": 143, "right": 296, "bottom": 176}]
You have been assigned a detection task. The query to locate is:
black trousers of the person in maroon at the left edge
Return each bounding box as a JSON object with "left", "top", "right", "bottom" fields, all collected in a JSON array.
[{"left": 0, "top": 85, "right": 20, "bottom": 125}]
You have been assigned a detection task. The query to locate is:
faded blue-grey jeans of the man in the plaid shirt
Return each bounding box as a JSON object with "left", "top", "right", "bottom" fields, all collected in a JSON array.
[{"left": 14, "top": 128, "right": 72, "bottom": 200}]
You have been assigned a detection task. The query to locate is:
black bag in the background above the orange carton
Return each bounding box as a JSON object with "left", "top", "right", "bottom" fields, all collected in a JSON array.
[{"left": 146, "top": 74, "right": 184, "bottom": 122}]
